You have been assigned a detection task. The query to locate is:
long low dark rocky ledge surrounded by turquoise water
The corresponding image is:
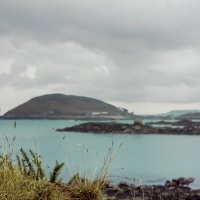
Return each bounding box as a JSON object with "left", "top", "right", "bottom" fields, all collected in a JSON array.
[{"left": 57, "top": 122, "right": 200, "bottom": 135}]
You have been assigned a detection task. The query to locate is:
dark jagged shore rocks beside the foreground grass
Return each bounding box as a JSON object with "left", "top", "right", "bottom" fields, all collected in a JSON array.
[{"left": 103, "top": 177, "right": 200, "bottom": 200}]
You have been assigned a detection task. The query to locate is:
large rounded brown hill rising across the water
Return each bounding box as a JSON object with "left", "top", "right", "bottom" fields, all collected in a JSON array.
[{"left": 3, "top": 94, "right": 133, "bottom": 119}]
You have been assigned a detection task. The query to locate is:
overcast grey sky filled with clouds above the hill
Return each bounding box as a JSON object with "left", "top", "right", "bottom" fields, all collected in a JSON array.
[{"left": 0, "top": 0, "right": 200, "bottom": 114}]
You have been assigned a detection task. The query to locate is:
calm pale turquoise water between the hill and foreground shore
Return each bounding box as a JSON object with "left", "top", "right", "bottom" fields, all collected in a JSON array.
[{"left": 0, "top": 120, "right": 200, "bottom": 188}]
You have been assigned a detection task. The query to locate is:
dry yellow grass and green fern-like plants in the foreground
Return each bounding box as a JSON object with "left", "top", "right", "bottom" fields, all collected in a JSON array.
[{"left": 0, "top": 149, "right": 107, "bottom": 200}]
